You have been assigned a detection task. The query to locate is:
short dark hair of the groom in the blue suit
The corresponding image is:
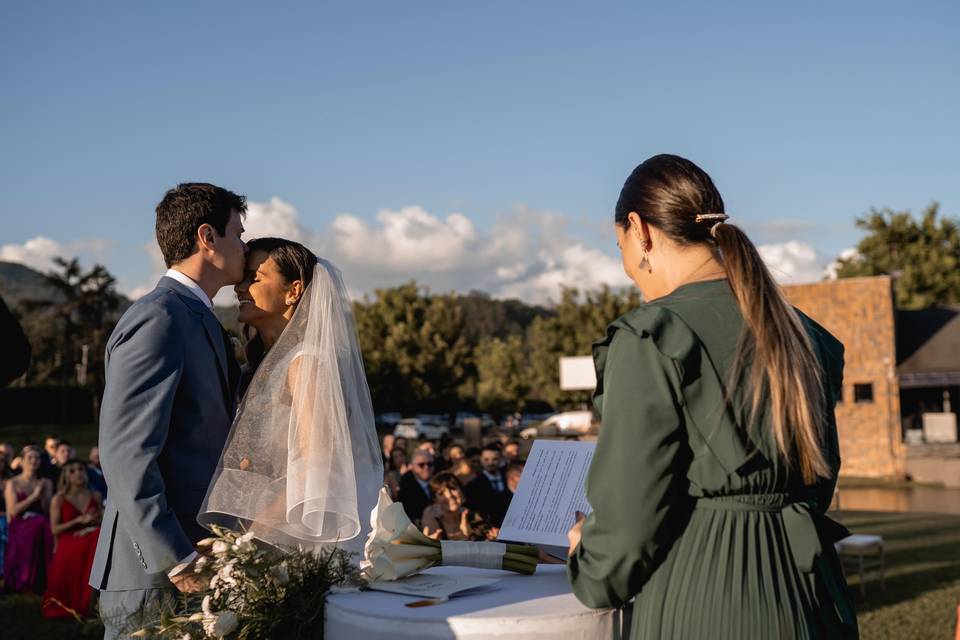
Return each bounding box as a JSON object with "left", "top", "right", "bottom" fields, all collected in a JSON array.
[{"left": 157, "top": 182, "right": 247, "bottom": 267}]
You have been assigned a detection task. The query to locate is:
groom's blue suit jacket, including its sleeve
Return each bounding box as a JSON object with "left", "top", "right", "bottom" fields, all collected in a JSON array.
[{"left": 90, "top": 277, "right": 236, "bottom": 591}]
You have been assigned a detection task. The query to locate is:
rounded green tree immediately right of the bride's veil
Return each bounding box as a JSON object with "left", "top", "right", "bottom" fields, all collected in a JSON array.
[{"left": 355, "top": 282, "right": 472, "bottom": 411}]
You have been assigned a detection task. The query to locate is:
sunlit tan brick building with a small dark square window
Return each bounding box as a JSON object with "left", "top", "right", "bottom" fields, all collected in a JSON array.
[{"left": 784, "top": 276, "right": 907, "bottom": 477}]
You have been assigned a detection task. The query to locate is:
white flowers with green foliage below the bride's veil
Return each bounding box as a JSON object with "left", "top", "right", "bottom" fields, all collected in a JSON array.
[{"left": 121, "top": 527, "right": 360, "bottom": 640}]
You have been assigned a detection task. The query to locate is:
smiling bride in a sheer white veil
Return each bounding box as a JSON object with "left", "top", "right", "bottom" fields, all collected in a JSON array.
[{"left": 197, "top": 238, "right": 383, "bottom": 561}]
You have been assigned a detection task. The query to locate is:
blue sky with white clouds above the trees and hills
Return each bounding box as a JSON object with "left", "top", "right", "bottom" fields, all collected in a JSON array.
[{"left": 0, "top": 1, "right": 960, "bottom": 298}]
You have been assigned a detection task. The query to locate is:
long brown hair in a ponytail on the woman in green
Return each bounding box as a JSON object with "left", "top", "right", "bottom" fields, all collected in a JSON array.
[{"left": 615, "top": 154, "right": 830, "bottom": 484}]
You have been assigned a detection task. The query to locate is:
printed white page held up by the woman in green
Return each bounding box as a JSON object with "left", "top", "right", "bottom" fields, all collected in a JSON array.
[{"left": 498, "top": 440, "right": 596, "bottom": 549}]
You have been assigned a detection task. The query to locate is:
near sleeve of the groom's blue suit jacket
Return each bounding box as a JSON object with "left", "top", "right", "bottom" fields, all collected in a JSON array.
[{"left": 100, "top": 304, "right": 194, "bottom": 572}]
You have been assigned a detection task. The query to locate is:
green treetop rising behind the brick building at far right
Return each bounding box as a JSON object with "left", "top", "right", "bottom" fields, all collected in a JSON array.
[{"left": 837, "top": 202, "right": 960, "bottom": 309}]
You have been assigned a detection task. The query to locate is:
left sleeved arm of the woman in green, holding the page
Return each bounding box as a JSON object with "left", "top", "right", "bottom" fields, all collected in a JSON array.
[{"left": 567, "top": 331, "right": 686, "bottom": 607}]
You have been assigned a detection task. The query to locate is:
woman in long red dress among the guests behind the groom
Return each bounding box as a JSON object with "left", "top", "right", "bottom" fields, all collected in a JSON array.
[{"left": 41, "top": 460, "right": 103, "bottom": 618}]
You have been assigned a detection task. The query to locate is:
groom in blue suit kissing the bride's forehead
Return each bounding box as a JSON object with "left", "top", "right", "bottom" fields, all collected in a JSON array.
[{"left": 90, "top": 183, "right": 246, "bottom": 638}]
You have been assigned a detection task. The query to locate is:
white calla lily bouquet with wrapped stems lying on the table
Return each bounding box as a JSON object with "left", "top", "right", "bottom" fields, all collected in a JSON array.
[{"left": 362, "top": 489, "right": 540, "bottom": 582}]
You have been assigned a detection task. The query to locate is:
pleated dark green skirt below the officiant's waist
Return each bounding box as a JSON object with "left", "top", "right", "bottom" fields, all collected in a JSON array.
[{"left": 631, "top": 494, "right": 856, "bottom": 640}]
